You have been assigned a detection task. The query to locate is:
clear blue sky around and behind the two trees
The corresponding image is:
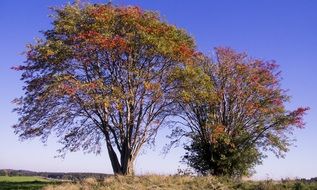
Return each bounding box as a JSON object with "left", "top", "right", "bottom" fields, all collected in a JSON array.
[{"left": 0, "top": 0, "right": 317, "bottom": 179}]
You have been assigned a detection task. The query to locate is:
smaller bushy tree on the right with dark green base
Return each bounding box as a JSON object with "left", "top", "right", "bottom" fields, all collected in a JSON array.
[{"left": 173, "top": 48, "right": 309, "bottom": 177}]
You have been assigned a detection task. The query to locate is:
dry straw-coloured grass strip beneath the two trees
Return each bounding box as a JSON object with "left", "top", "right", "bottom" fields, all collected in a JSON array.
[{"left": 44, "top": 175, "right": 317, "bottom": 190}]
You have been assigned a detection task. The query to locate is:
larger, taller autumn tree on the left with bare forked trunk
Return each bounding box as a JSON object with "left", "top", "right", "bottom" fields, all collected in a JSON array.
[{"left": 13, "top": 4, "right": 194, "bottom": 175}]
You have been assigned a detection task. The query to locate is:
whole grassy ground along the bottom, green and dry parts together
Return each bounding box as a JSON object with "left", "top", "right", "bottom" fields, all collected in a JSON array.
[{"left": 0, "top": 175, "right": 317, "bottom": 190}]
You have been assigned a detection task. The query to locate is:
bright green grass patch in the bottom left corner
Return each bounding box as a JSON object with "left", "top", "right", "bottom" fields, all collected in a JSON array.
[{"left": 0, "top": 176, "right": 54, "bottom": 190}]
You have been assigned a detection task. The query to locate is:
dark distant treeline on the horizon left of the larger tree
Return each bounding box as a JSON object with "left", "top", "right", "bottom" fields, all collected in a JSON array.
[{"left": 0, "top": 169, "right": 111, "bottom": 181}]
